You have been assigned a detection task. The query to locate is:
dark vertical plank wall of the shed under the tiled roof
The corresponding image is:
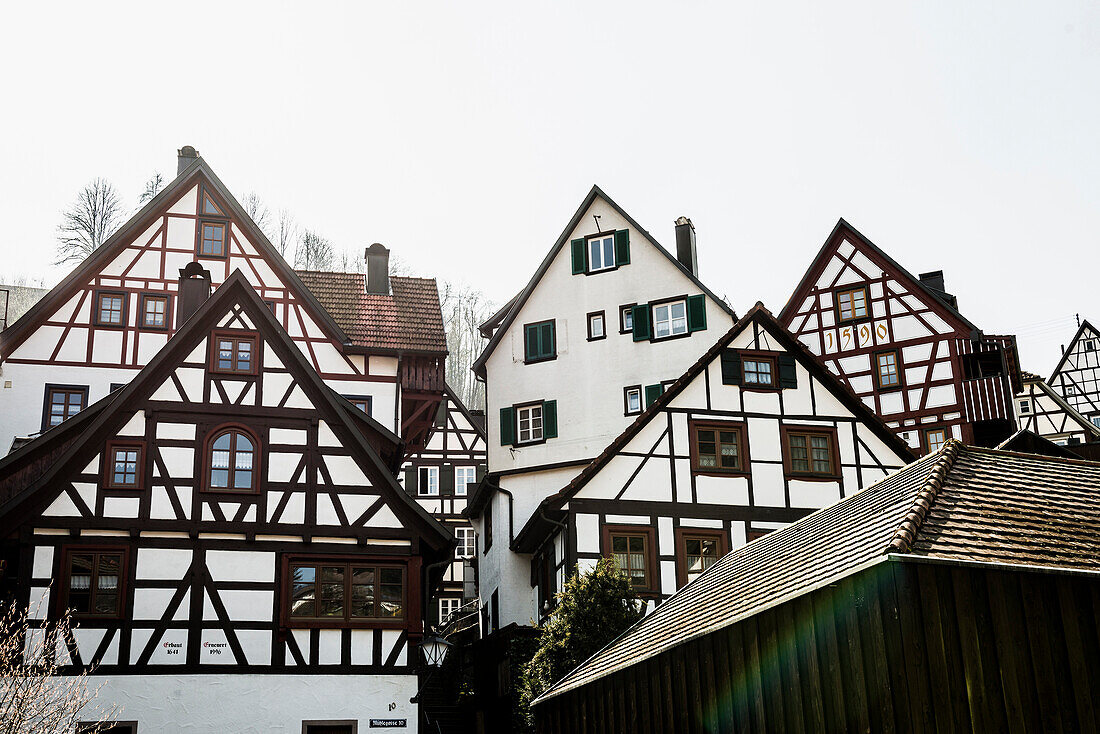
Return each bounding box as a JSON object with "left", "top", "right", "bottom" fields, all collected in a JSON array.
[{"left": 535, "top": 562, "right": 1100, "bottom": 734}]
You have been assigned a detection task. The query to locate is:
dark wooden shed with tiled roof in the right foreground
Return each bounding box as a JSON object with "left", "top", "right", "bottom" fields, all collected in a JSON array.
[{"left": 534, "top": 441, "right": 1100, "bottom": 734}]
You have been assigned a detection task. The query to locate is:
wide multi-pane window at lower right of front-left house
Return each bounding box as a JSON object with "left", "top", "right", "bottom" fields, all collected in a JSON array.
[{"left": 287, "top": 559, "right": 405, "bottom": 626}]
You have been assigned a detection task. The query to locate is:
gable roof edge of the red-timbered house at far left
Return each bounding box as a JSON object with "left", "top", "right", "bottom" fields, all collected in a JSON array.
[{"left": 0, "top": 157, "right": 349, "bottom": 360}]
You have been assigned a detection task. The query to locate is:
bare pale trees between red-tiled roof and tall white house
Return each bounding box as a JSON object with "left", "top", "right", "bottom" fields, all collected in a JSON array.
[{"left": 439, "top": 281, "right": 494, "bottom": 409}]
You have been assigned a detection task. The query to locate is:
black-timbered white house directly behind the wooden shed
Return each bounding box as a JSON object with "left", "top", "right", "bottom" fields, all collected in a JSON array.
[{"left": 514, "top": 304, "right": 915, "bottom": 614}]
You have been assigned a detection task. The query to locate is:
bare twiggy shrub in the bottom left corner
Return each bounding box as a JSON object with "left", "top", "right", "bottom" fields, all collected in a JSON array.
[{"left": 0, "top": 600, "right": 119, "bottom": 734}]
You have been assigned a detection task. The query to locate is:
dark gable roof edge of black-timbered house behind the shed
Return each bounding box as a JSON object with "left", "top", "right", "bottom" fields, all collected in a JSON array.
[{"left": 510, "top": 302, "right": 915, "bottom": 551}]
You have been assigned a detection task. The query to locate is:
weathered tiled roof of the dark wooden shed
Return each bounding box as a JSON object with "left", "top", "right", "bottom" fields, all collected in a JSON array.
[{"left": 535, "top": 440, "right": 1100, "bottom": 704}]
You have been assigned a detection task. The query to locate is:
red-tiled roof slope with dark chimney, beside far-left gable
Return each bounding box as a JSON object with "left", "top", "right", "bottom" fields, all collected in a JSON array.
[{"left": 297, "top": 271, "right": 447, "bottom": 354}]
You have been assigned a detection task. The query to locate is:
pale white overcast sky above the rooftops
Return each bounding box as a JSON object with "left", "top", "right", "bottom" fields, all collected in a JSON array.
[{"left": 0, "top": 0, "right": 1100, "bottom": 374}]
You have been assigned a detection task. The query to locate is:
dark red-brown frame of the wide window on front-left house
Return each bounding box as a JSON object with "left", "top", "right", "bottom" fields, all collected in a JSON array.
[{"left": 276, "top": 554, "right": 409, "bottom": 629}]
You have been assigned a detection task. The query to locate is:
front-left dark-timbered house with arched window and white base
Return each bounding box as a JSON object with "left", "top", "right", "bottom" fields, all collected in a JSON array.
[{"left": 0, "top": 271, "right": 453, "bottom": 733}]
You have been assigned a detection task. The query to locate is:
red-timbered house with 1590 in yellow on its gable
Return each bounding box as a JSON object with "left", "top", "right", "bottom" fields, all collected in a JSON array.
[{"left": 780, "top": 219, "right": 1020, "bottom": 452}]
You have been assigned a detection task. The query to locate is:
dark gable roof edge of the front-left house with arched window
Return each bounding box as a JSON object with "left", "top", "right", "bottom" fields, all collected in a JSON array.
[{"left": 0, "top": 271, "right": 454, "bottom": 552}]
